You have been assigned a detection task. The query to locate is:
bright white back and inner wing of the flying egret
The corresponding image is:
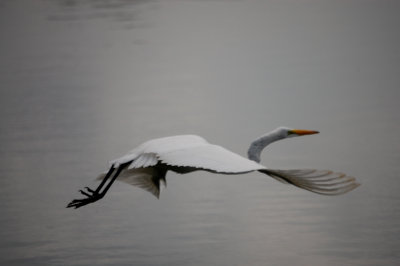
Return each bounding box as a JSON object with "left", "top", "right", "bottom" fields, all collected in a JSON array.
[{"left": 111, "top": 135, "right": 265, "bottom": 174}]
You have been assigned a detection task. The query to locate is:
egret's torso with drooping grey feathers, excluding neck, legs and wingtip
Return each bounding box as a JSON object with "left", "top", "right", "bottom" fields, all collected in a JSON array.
[{"left": 98, "top": 135, "right": 266, "bottom": 197}]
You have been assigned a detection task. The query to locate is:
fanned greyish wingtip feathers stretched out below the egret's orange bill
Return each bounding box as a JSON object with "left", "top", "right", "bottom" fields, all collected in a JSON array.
[{"left": 260, "top": 169, "right": 360, "bottom": 195}]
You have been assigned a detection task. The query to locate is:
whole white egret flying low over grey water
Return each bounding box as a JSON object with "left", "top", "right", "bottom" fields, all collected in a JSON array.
[{"left": 67, "top": 127, "right": 359, "bottom": 208}]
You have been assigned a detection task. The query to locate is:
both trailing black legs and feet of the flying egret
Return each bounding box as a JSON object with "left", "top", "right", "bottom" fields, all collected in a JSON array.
[{"left": 67, "top": 164, "right": 127, "bottom": 209}]
